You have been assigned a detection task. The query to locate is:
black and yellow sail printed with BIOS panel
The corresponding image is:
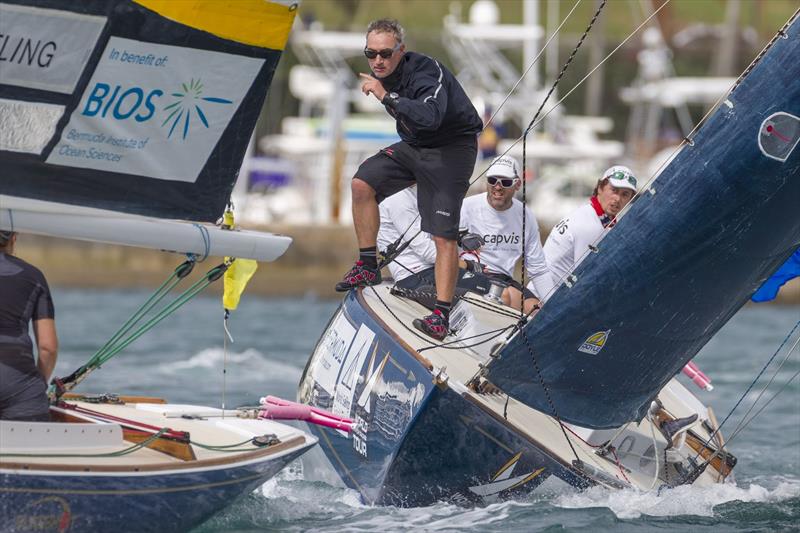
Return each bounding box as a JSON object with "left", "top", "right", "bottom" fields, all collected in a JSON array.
[{"left": 0, "top": 0, "right": 297, "bottom": 222}]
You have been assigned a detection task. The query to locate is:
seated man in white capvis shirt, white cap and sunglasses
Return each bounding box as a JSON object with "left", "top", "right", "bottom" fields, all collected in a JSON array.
[{"left": 461, "top": 156, "right": 554, "bottom": 313}]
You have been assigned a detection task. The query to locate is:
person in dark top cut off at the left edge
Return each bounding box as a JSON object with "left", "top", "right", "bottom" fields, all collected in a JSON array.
[{"left": 0, "top": 231, "right": 58, "bottom": 421}]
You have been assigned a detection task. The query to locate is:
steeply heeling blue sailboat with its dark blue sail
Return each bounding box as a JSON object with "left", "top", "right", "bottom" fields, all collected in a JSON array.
[{"left": 298, "top": 13, "right": 800, "bottom": 506}]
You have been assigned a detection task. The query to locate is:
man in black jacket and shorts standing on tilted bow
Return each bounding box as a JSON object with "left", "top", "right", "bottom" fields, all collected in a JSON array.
[{"left": 336, "top": 19, "right": 482, "bottom": 340}]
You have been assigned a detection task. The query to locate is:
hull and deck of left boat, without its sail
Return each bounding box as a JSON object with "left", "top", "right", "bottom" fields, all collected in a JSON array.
[{"left": 0, "top": 396, "right": 316, "bottom": 532}]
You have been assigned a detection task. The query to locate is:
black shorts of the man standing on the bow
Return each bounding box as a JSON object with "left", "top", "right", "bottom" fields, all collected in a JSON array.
[{"left": 355, "top": 135, "right": 478, "bottom": 240}]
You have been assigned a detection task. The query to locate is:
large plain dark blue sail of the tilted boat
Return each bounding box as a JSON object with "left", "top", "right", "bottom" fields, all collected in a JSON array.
[{"left": 487, "top": 14, "right": 800, "bottom": 428}]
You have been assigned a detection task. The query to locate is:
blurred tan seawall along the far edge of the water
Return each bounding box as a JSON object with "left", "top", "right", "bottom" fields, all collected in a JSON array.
[{"left": 16, "top": 226, "right": 800, "bottom": 305}]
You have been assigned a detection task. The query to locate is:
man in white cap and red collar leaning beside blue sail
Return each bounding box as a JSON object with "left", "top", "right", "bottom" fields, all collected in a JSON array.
[{"left": 544, "top": 165, "right": 636, "bottom": 284}]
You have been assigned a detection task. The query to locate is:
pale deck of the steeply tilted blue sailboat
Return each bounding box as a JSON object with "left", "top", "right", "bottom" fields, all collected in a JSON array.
[{"left": 361, "top": 283, "right": 718, "bottom": 488}]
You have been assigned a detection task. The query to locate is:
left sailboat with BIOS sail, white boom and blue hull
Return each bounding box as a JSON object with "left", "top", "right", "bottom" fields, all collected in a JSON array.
[{"left": 0, "top": 0, "right": 317, "bottom": 531}]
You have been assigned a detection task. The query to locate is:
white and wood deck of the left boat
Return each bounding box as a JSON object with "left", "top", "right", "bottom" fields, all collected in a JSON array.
[{"left": 0, "top": 400, "right": 313, "bottom": 471}]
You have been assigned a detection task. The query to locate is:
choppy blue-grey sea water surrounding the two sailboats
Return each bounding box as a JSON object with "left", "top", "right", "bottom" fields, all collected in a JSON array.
[{"left": 54, "top": 290, "right": 800, "bottom": 533}]
